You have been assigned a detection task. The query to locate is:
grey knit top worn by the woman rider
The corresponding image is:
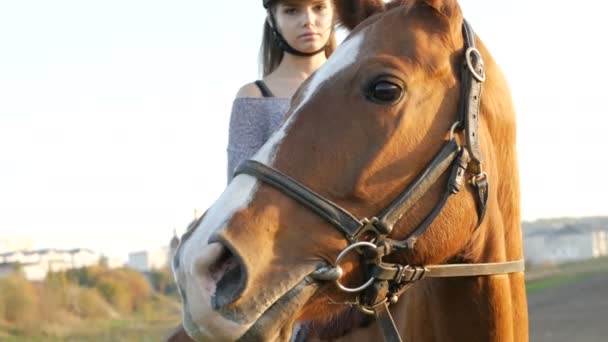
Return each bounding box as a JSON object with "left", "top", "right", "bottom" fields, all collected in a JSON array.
[{"left": 227, "top": 97, "right": 290, "bottom": 183}]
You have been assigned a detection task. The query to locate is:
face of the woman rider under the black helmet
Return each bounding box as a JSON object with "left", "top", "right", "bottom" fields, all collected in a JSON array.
[{"left": 275, "top": 0, "right": 334, "bottom": 52}]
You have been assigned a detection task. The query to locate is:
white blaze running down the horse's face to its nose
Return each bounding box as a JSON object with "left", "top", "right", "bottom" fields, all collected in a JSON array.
[{"left": 177, "top": 27, "right": 364, "bottom": 340}]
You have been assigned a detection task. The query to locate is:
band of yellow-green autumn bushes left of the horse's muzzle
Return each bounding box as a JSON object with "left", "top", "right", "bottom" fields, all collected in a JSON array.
[{"left": 0, "top": 266, "right": 177, "bottom": 339}]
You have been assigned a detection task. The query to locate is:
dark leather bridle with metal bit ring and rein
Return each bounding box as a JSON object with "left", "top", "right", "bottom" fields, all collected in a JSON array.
[{"left": 234, "top": 20, "right": 524, "bottom": 341}]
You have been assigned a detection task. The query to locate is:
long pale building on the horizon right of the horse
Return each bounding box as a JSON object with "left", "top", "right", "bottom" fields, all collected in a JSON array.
[{"left": 523, "top": 222, "right": 608, "bottom": 264}]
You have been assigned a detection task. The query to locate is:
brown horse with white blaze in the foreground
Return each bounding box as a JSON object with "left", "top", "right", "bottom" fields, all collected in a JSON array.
[{"left": 173, "top": 0, "right": 528, "bottom": 342}]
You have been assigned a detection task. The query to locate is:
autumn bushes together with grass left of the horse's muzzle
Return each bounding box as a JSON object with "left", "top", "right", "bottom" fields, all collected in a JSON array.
[{"left": 0, "top": 266, "right": 181, "bottom": 342}]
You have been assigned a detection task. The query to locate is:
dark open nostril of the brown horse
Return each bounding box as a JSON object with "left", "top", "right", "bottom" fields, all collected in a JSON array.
[{"left": 209, "top": 246, "right": 245, "bottom": 310}]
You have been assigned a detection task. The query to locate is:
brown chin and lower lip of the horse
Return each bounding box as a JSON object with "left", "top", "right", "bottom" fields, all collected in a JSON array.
[{"left": 238, "top": 277, "right": 319, "bottom": 342}]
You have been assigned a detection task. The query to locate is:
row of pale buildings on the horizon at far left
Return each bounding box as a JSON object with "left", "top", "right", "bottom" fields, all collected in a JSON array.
[{"left": 0, "top": 248, "right": 100, "bottom": 281}]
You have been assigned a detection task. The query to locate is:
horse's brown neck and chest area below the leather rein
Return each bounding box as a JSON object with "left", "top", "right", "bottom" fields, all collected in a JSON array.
[{"left": 393, "top": 274, "right": 528, "bottom": 342}]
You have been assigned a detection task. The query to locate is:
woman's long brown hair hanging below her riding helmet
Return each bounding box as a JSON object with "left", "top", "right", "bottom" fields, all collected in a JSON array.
[{"left": 260, "top": 0, "right": 336, "bottom": 77}]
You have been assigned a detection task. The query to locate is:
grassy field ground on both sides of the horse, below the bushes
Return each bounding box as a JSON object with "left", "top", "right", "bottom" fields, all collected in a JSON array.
[{"left": 0, "top": 258, "right": 608, "bottom": 342}]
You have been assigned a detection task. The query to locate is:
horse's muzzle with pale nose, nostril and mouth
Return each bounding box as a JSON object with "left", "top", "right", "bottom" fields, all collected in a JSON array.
[{"left": 175, "top": 237, "right": 319, "bottom": 341}]
